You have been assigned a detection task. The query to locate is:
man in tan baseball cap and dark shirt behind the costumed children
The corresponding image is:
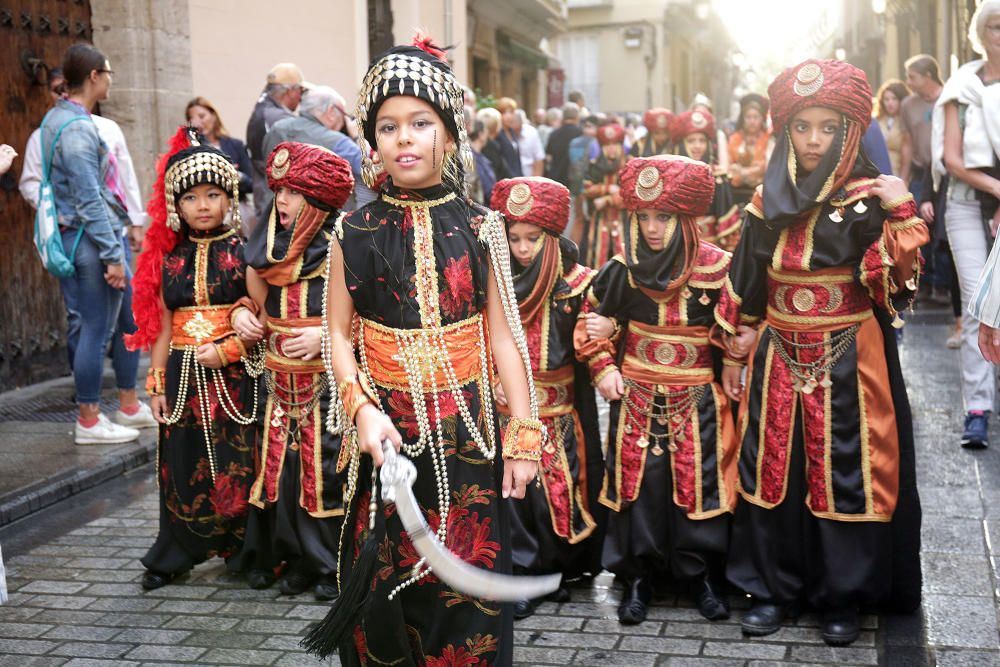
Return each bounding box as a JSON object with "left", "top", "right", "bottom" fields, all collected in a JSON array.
[{"left": 247, "top": 63, "right": 306, "bottom": 220}]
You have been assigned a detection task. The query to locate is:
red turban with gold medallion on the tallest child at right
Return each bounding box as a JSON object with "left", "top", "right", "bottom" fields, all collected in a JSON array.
[{"left": 767, "top": 59, "right": 872, "bottom": 132}]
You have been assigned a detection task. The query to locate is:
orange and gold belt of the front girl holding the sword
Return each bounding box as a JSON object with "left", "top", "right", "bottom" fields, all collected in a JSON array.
[{"left": 358, "top": 315, "right": 489, "bottom": 391}]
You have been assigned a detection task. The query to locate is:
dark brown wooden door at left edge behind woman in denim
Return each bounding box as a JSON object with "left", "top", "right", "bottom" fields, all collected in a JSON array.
[{"left": 0, "top": 0, "right": 91, "bottom": 390}]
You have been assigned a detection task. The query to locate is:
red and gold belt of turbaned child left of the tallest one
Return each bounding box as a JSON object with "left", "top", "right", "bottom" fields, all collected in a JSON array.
[{"left": 622, "top": 322, "right": 715, "bottom": 386}]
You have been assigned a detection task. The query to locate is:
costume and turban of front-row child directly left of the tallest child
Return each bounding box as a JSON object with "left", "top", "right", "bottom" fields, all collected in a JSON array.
[{"left": 575, "top": 156, "right": 737, "bottom": 608}]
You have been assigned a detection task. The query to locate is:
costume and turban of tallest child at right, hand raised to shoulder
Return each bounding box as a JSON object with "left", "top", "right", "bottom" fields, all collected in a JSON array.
[{"left": 717, "top": 61, "right": 927, "bottom": 609}]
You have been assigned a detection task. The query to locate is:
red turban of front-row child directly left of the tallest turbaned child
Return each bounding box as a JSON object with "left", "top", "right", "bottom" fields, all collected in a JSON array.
[{"left": 618, "top": 155, "right": 715, "bottom": 216}]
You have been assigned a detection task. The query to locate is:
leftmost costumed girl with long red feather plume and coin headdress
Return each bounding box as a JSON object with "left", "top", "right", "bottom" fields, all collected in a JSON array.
[{"left": 128, "top": 128, "right": 261, "bottom": 589}]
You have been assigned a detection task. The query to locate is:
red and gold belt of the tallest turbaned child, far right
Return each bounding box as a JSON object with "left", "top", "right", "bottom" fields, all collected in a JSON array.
[{"left": 767, "top": 266, "right": 872, "bottom": 331}]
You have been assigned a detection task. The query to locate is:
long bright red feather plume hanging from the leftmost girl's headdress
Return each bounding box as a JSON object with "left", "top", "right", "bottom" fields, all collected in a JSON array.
[{"left": 125, "top": 126, "right": 191, "bottom": 350}]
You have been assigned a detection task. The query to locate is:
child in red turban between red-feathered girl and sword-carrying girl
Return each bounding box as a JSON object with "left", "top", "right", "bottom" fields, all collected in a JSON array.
[{"left": 233, "top": 142, "right": 354, "bottom": 600}]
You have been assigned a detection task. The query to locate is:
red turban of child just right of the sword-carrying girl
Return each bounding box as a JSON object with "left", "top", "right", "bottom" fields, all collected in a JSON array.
[{"left": 490, "top": 176, "right": 569, "bottom": 236}]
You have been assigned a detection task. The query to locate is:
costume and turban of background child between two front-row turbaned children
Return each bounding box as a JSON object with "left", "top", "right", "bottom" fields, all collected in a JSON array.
[{"left": 580, "top": 123, "right": 625, "bottom": 269}]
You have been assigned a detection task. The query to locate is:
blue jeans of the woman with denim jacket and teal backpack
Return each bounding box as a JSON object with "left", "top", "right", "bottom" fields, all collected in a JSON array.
[{"left": 60, "top": 229, "right": 125, "bottom": 404}]
